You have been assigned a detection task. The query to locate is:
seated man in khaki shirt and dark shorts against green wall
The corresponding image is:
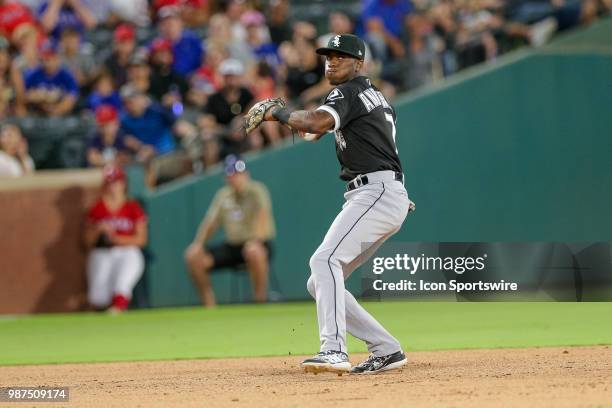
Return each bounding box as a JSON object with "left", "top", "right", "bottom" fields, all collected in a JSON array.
[{"left": 185, "top": 155, "right": 275, "bottom": 307}]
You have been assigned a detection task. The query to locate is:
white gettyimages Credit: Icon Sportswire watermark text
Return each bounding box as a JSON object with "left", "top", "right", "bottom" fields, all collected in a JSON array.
[{"left": 371, "top": 253, "right": 518, "bottom": 293}]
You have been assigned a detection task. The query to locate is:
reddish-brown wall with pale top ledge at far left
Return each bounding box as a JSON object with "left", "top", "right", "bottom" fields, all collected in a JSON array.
[{"left": 0, "top": 170, "right": 100, "bottom": 314}]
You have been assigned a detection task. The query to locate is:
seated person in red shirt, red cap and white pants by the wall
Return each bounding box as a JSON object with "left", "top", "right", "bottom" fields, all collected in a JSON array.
[{"left": 85, "top": 165, "right": 147, "bottom": 312}]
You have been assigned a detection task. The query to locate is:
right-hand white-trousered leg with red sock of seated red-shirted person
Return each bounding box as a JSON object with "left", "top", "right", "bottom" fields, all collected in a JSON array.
[{"left": 112, "top": 246, "right": 145, "bottom": 311}]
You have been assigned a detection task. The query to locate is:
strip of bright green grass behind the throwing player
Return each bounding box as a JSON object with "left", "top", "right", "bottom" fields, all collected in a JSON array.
[{"left": 0, "top": 302, "right": 612, "bottom": 365}]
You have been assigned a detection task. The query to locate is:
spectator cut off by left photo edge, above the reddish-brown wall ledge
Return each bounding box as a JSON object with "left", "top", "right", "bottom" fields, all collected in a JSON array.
[{"left": 0, "top": 37, "right": 26, "bottom": 120}]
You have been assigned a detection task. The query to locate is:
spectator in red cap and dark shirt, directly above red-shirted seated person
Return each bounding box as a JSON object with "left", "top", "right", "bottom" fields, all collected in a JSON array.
[{"left": 87, "top": 105, "right": 131, "bottom": 167}]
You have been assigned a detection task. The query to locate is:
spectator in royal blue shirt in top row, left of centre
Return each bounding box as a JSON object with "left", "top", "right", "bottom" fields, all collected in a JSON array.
[{"left": 158, "top": 6, "right": 203, "bottom": 77}]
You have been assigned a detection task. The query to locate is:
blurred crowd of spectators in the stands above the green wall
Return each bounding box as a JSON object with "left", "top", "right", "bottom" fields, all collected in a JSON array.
[{"left": 0, "top": 0, "right": 612, "bottom": 185}]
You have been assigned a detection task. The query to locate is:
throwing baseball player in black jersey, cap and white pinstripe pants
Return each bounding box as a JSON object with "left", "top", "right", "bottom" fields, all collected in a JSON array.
[{"left": 245, "top": 34, "right": 414, "bottom": 374}]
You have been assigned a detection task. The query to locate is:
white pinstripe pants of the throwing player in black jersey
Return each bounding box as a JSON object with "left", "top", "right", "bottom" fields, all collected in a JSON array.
[{"left": 307, "top": 181, "right": 410, "bottom": 356}]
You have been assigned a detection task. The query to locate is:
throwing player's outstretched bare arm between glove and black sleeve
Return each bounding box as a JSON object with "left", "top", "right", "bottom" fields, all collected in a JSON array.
[{"left": 264, "top": 108, "right": 336, "bottom": 139}]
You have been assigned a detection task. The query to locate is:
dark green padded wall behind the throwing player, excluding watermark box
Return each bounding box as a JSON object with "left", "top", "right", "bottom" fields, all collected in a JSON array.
[{"left": 144, "top": 21, "right": 612, "bottom": 306}]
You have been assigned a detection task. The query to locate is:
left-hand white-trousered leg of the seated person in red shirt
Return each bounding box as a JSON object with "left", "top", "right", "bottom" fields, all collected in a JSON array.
[{"left": 87, "top": 248, "right": 112, "bottom": 309}]
